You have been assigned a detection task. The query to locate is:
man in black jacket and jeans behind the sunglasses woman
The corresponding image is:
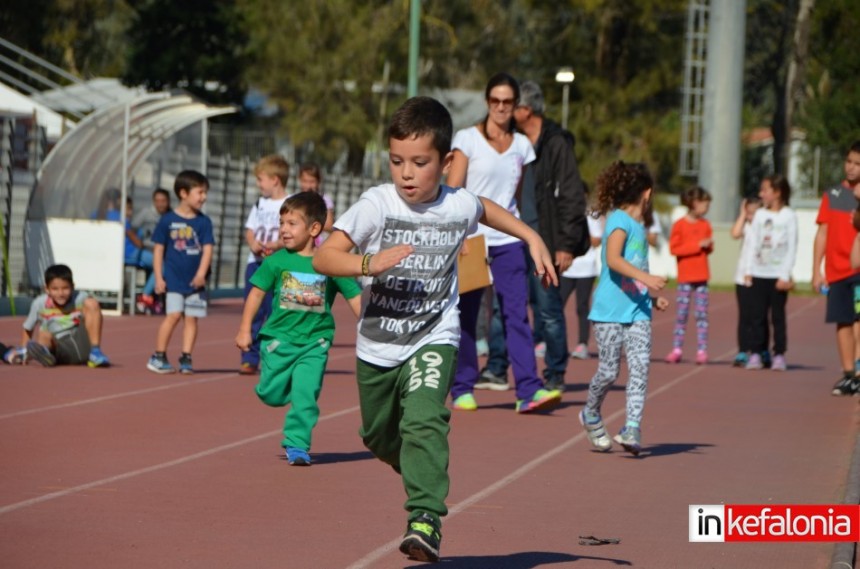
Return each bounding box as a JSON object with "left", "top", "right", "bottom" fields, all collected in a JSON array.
[{"left": 514, "top": 81, "right": 590, "bottom": 389}]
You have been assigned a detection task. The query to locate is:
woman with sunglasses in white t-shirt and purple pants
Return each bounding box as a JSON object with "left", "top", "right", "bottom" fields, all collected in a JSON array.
[{"left": 447, "top": 73, "right": 561, "bottom": 413}]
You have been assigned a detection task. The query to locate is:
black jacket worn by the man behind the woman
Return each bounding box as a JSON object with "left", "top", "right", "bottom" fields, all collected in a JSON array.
[{"left": 529, "top": 117, "right": 591, "bottom": 257}]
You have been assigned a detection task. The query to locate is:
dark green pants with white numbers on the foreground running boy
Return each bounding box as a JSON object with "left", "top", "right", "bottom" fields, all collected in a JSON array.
[{"left": 356, "top": 345, "right": 457, "bottom": 519}]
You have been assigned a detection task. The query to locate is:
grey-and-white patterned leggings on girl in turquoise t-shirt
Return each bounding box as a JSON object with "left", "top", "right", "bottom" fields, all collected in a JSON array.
[{"left": 585, "top": 320, "right": 651, "bottom": 425}]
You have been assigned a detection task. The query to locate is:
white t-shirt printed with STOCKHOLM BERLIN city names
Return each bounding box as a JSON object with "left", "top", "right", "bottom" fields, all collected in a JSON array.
[{"left": 334, "top": 184, "right": 484, "bottom": 367}]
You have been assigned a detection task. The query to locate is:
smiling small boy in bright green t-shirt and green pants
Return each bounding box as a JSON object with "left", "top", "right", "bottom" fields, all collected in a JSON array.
[{"left": 236, "top": 192, "right": 361, "bottom": 466}]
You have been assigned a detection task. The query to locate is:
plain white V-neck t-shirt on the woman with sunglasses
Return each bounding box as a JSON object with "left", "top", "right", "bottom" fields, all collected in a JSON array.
[{"left": 451, "top": 126, "right": 535, "bottom": 247}]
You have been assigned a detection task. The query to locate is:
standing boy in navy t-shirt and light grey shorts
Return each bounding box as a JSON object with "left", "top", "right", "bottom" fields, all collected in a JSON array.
[{"left": 146, "top": 170, "right": 215, "bottom": 374}]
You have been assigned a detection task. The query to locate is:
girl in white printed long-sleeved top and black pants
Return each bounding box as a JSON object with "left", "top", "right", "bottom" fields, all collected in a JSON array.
[{"left": 743, "top": 174, "right": 797, "bottom": 371}]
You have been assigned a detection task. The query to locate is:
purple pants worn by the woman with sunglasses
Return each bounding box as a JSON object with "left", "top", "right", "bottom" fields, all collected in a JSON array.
[{"left": 451, "top": 242, "right": 543, "bottom": 399}]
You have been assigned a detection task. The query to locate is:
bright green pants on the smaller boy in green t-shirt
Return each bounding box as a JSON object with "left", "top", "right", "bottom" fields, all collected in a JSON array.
[{"left": 256, "top": 338, "right": 331, "bottom": 451}]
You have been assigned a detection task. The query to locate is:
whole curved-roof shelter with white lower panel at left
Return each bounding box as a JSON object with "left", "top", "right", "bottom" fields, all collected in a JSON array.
[{"left": 24, "top": 93, "right": 236, "bottom": 312}]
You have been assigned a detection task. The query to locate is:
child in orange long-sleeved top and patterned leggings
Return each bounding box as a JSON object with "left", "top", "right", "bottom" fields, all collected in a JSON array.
[{"left": 666, "top": 186, "right": 714, "bottom": 364}]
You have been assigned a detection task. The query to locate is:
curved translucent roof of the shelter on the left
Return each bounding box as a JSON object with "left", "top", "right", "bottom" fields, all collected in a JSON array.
[{"left": 27, "top": 93, "right": 236, "bottom": 221}]
